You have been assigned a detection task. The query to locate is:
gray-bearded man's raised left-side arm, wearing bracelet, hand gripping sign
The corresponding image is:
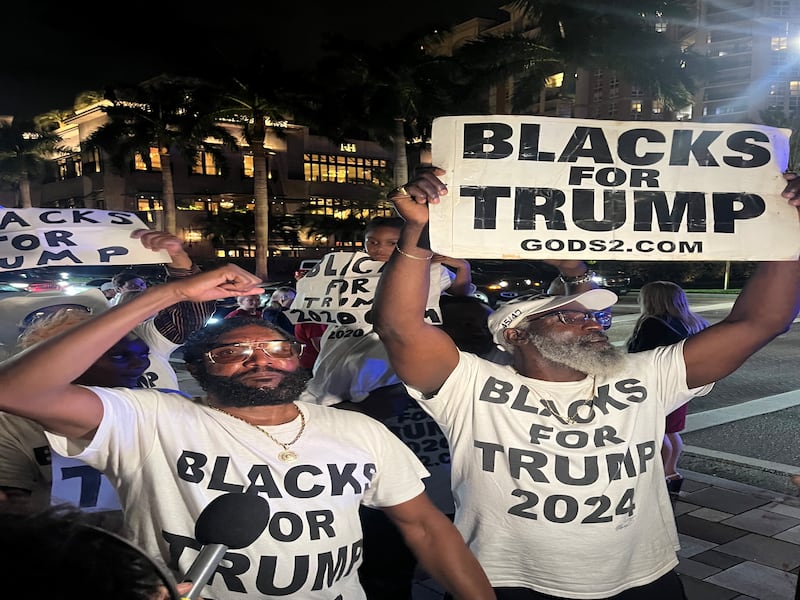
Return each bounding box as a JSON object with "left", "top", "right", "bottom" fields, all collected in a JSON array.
[{"left": 373, "top": 169, "right": 458, "bottom": 393}]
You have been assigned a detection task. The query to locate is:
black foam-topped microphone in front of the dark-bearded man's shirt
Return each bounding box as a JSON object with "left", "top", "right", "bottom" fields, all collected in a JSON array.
[{"left": 183, "top": 493, "right": 269, "bottom": 600}]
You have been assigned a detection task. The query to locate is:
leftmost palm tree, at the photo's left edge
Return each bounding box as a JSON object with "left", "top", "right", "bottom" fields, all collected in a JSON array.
[{"left": 0, "top": 121, "right": 68, "bottom": 208}]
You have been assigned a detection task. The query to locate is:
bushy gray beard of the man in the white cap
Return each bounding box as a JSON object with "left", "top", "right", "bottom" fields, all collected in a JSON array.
[{"left": 528, "top": 334, "right": 627, "bottom": 377}]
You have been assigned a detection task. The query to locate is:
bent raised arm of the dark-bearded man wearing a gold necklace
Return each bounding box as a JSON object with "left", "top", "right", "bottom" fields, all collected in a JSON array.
[{"left": 0, "top": 265, "right": 263, "bottom": 437}]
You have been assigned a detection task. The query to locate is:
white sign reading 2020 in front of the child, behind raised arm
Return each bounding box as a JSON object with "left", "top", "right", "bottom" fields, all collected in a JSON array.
[{"left": 286, "top": 252, "right": 442, "bottom": 327}]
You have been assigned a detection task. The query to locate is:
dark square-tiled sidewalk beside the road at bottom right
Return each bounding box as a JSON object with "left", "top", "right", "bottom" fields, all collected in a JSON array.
[{"left": 414, "top": 471, "right": 800, "bottom": 600}]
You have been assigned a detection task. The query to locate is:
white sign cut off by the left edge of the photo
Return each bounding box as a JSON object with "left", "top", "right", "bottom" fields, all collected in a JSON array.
[{"left": 0, "top": 208, "right": 170, "bottom": 272}]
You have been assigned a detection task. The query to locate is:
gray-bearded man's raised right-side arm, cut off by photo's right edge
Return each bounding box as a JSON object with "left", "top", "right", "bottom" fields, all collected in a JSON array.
[{"left": 683, "top": 174, "right": 800, "bottom": 387}]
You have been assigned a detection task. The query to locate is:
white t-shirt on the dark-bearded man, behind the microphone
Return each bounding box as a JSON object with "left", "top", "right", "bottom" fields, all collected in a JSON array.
[{"left": 48, "top": 388, "right": 427, "bottom": 600}]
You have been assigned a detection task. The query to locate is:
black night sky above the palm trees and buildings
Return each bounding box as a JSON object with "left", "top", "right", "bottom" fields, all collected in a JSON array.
[{"left": 0, "top": 0, "right": 504, "bottom": 118}]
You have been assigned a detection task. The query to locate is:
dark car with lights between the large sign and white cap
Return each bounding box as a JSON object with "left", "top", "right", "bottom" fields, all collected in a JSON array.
[{"left": 469, "top": 259, "right": 558, "bottom": 307}]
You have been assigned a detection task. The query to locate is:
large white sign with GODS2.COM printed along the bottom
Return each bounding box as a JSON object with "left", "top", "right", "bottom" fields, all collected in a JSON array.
[{"left": 430, "top": 115, "right": 800, "bottom": 261}]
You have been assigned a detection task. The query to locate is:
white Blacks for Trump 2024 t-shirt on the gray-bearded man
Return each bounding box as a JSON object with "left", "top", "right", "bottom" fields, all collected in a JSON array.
[{"left": 409, "top": 343, "right": 711, "bottom": 598}]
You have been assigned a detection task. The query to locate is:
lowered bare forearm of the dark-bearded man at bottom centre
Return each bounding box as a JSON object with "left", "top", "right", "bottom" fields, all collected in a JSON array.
[{"left": 406, "top": 515, "right": 495, "bottom": 600}]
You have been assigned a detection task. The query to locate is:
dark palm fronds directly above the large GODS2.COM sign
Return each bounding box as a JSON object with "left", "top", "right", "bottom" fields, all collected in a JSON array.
[{"left": 455, "top": 0, "right": 703, "bottom": 111}]
